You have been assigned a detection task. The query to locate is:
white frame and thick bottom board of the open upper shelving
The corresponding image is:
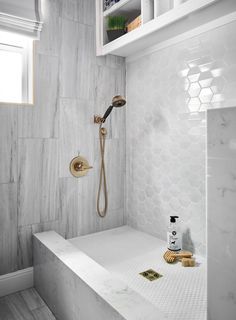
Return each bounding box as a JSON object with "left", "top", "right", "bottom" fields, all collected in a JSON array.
[{"left": 97, "top": 0, "right": 236, "bottom": 57}]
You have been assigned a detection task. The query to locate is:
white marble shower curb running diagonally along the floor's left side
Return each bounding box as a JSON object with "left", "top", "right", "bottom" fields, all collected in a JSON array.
[{"left": 34, "top": 232, "right": 162, "bottom": 320}]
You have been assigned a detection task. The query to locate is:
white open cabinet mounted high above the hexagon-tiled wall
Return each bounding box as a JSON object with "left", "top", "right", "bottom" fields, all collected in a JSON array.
[{"left": 96, "top": 0, "right": 236, "bottom": 57}]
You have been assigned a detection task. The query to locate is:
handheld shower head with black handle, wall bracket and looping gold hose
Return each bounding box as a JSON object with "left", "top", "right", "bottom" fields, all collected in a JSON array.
[{"left": 94, "top": 96, "right": 126, "bottom": 218}]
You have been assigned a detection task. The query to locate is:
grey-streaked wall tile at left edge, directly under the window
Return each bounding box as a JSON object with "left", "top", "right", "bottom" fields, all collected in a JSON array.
[{"left": 0, "top": 107, "right": 17, "bottom": 183}]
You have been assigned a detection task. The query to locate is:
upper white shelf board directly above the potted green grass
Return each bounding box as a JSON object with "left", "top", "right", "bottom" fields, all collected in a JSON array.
[{"left": 103, "top": 0, "right": 141, "bottom": 17}]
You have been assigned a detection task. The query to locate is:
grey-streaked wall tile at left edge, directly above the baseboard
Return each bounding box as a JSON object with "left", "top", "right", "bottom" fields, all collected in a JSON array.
[{"left": 0, "top": 183, "right": 17, "bottom": 275}]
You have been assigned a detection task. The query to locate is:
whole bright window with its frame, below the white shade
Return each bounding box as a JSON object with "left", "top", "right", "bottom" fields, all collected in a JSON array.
[{"left": 0, "top": 31, "right": 33, "bottom": 104}]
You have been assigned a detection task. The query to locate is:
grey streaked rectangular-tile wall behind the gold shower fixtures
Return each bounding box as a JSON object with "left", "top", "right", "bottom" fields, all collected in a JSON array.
[{"left": 0, "top": 0, "right": 125, "bottom": 274}]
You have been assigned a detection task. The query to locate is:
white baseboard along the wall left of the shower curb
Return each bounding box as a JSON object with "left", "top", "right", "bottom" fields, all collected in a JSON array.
[{"left": 0, "top": 268, "right": 34, "bottom": 297}]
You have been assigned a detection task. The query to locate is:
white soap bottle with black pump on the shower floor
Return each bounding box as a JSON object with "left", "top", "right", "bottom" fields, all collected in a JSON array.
[{"left": 167, "top": 216, "right": 182, "bottom": 251}]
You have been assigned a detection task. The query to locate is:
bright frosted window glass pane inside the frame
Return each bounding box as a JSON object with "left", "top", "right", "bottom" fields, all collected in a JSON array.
[{"left": 0, "top": 50, "right": 23, "bottom": 103}]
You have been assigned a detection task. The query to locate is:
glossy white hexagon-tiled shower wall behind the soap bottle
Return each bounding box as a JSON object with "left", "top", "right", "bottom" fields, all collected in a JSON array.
[{"left": 126, "top": 23, "right": 236, "bottom": 254}]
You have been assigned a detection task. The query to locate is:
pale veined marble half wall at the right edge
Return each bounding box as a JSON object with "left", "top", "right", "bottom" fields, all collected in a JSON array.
[{"left": 208, "top": 108, "right": 236, "bottom": 320}]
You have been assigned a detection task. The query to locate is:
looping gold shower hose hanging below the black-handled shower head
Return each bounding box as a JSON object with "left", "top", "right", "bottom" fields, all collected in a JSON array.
[{"left": 97, "top": 123, "right": 108, "bottom": 218}]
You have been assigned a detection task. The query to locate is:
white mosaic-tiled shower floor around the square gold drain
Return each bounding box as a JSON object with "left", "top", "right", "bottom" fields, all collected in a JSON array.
[{"left": 69, "top": 226, "right": 207, "bottom": 320}]
